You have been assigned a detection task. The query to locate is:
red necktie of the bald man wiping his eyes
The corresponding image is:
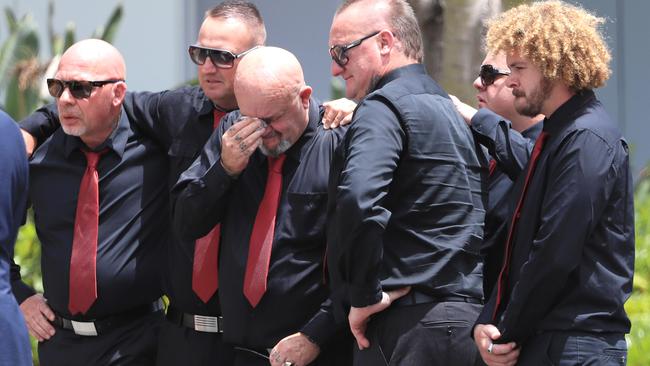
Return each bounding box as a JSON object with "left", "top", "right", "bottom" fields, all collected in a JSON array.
[{"left": 244, "top": 154, "right": 286, "bottom": 307}]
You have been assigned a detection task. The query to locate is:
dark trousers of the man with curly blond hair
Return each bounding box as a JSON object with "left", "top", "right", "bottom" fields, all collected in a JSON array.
[{"left": 517, "top": 331, "right": 627, "bottom": 366}]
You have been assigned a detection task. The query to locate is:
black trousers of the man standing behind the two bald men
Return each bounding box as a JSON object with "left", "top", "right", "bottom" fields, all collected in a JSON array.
[{"left": 156, "top": 320, "right": 234, "bottom": 366}]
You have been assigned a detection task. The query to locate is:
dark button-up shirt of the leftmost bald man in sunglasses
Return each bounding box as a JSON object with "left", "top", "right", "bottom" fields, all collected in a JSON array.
[{"left": 14, "top": 108, "right": 169, "bottom": 319}]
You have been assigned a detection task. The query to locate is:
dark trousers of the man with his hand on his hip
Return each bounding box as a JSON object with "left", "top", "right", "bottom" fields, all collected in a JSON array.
[{"left": 354, "top": 302, "right": 482, "bottom": 366}]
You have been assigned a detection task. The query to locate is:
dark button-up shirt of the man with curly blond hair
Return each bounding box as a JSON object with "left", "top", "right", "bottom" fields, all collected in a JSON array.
[{"left": 470, "top": 91, "right": 634, "bottom": 344}]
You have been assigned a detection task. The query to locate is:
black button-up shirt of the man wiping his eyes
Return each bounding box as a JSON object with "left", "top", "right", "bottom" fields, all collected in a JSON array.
[{"left": 173, "top": 99, "right": 346, "bottom": 349}]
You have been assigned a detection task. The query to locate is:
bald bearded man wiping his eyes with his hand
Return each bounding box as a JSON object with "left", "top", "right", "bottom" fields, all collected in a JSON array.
[{"left": 172, "top": 47, "right": 348, "bottom": 366}]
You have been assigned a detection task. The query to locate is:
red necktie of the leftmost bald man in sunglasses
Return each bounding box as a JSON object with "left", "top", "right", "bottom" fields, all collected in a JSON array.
[{"left": 68, "top": 150, "right": 107, "bottom": 315}]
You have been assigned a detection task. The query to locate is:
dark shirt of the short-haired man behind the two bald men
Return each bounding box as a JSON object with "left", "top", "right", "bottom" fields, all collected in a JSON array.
[{"left": 21, "top": 87, "right": 227, "bottom": 315}]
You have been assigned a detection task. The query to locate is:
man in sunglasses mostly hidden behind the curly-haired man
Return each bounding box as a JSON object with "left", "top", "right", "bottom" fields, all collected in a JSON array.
[{"left": 452, "top": 52, "right": 544, "bottom": 298}]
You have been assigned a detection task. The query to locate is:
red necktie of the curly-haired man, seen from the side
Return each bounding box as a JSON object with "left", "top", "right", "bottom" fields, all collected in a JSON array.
[{"left": 492, "top": 132, "right": 548, "bottom": 320}]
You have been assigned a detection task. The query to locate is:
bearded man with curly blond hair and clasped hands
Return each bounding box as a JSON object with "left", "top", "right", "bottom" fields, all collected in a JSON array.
[{"left": 473, "top": 1, "right": 634, "bottom": 365}]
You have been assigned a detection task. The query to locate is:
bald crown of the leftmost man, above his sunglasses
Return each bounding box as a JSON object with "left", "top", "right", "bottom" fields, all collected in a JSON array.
[{"left": 59, "top": 39, "right": 126, "bottom": 80}]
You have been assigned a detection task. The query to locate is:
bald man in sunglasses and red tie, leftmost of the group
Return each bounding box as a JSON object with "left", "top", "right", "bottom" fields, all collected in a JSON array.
[{"left": 13, "top": 39, "right": 169, "bottom": 365}]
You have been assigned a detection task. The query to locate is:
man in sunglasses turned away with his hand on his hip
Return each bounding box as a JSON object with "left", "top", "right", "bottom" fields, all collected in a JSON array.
[{"left": 327, "top": 0, "right": 485, "bottom": 365}]
